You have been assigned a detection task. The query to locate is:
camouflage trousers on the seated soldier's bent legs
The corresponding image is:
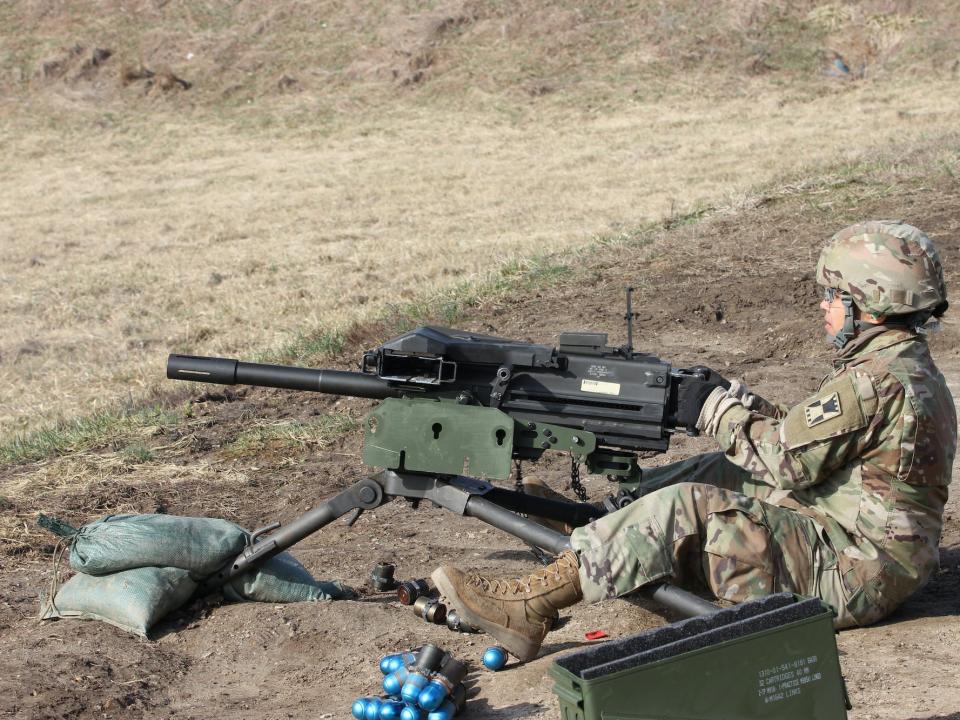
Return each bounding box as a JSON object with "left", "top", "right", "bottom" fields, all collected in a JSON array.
[{"left": 570, "top": 453, "right": 852, "bottom": 627}]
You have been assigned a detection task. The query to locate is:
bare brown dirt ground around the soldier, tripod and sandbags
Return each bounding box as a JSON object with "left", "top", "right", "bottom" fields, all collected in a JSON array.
[{"left": 0, "top": 160, "right": 960, "bottom": 720}]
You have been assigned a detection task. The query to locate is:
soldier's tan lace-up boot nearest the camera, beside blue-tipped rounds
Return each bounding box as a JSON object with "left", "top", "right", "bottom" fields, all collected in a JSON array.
[{"left": 430, "top": 550, "right": 583, "bottom": 662}]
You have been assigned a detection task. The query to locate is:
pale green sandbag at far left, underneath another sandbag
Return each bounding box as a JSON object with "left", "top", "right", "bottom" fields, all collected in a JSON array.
[{"left": 40, "top": 567, "right": 197, "bottom": 638}]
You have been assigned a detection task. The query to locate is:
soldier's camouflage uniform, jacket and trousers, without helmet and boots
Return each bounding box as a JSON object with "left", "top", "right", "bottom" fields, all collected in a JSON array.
[{"left": 570, "top": 326, "right": 956, "bottom": 627}]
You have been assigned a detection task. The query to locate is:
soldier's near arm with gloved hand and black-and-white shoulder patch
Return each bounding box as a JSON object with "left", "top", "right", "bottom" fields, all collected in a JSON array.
[{"left": 709, "top": 371, "right": 904, "bottom": 489}]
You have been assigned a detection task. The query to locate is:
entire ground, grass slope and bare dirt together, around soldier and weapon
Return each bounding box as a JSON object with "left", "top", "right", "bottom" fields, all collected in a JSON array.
[{"left": 0, "top": 7, "right": 960, "bottom": 720}]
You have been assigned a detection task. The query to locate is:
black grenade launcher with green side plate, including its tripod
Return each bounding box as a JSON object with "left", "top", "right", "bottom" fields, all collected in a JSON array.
[{"left": 167, "top": 322, "right": 716, "bottom": 614}]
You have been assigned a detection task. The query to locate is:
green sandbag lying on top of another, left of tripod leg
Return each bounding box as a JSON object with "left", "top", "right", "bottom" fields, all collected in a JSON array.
[{"left": 70, "top": 515, "right": 248, "bottom": 580}]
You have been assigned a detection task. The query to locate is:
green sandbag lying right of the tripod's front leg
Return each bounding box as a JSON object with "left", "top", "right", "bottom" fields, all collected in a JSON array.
[{"left": 223, "top": 553, "right": 356, "bottom": 603}]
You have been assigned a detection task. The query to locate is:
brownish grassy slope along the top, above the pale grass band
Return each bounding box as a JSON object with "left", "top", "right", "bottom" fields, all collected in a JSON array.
[{"left": 0, "top": 0, "right": 960, "bottom": 114}]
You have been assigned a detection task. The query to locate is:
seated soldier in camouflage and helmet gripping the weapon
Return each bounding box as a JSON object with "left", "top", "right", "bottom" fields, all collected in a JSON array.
[{"left": 433, "top": 221, "right": 957, "bottom": 661}]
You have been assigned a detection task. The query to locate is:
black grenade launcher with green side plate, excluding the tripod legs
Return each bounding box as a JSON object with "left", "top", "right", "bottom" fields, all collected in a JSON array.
[{"left": 167, "top": 327, "right": 693, "bottom": 481}]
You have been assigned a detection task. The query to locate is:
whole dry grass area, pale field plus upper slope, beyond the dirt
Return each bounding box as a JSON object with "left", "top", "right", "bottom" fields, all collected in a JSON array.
[{"left": 0, "top": 0, "right": 960, "bottom": 435}]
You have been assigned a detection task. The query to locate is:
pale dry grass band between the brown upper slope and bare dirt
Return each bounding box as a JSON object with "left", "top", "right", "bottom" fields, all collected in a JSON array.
[{"left": 0, "top": 74, "right": 960, "bottom": 432}]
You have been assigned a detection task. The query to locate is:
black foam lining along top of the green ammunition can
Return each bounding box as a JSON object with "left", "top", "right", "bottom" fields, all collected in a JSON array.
[{"left": 556, "top": 593, "right": 823, "bottom": 680}]
